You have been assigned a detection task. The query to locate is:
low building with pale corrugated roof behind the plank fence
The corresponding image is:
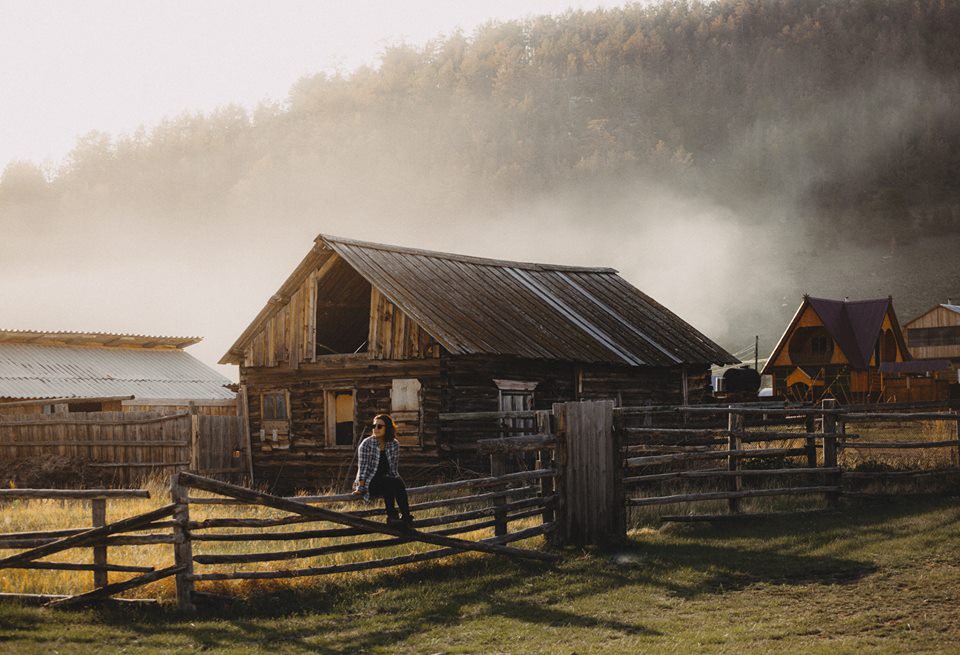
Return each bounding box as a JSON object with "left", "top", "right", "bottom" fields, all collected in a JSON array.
[{"left": 0, "top": 330, "right": 237, "bottom": 416}]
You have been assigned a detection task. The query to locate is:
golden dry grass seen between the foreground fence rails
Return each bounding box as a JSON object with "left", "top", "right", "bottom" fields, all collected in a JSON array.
[{"left": 0, "top": 479, "right": 539, "bottom": 600}]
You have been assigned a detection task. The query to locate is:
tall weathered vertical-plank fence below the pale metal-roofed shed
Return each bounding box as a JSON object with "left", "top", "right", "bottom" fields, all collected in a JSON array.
[{"left": 0, "top": 409, "right": 247, "bottom": 486}]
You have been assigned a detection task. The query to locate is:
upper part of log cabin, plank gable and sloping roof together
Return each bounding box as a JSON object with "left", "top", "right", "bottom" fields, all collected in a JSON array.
[{"left": 221, "top": 235, "right": 736, "bottom": 367}]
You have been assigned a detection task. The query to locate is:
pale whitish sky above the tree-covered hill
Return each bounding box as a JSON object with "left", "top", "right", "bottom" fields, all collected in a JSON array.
[{"left": 0, "top": 0, "right": 623, "bottom": 168}]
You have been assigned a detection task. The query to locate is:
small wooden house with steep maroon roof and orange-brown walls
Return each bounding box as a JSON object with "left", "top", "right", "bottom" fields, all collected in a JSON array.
[{"left": 762, "top": 296, "right": 910, "bottom": 402}]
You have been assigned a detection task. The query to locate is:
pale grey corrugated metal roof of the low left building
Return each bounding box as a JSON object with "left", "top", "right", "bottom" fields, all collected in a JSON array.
[{"left": 0, "top": 343, "right": 235, "bottom": 400}]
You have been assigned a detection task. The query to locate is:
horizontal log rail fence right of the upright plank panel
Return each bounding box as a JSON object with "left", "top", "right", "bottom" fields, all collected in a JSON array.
[{"left": 616, "top": 400, "right": 960, "bottom": 521}]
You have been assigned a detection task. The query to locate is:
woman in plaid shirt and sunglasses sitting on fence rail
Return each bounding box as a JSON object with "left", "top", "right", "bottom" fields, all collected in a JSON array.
[{"left": 353, "top": 414, "right": 413, "bottom": 528}]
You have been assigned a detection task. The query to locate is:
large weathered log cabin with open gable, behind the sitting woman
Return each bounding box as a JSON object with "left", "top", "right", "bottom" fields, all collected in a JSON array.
[{"left": 220, "top": 235, "right": 736, "bottom": 489}]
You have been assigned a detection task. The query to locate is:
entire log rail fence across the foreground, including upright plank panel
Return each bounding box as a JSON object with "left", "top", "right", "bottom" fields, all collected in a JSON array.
[{"left": 0, "top": 401, "right": 960, "bottom": 610}]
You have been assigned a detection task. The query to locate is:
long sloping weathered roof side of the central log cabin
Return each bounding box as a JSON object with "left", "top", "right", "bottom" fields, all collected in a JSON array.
[{"left": 317, "top": 235, "right": 737, "bottom": 366}]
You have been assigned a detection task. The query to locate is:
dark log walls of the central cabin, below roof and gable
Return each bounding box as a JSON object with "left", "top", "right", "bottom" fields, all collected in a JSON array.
[{"left": 241, "top": 352, "right": 709, "bottom": 491}]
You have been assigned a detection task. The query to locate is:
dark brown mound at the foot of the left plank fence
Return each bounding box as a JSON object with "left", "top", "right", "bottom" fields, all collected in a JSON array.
[{"left": 0, "top": 455, "right": 112, "bottom": 489}]
